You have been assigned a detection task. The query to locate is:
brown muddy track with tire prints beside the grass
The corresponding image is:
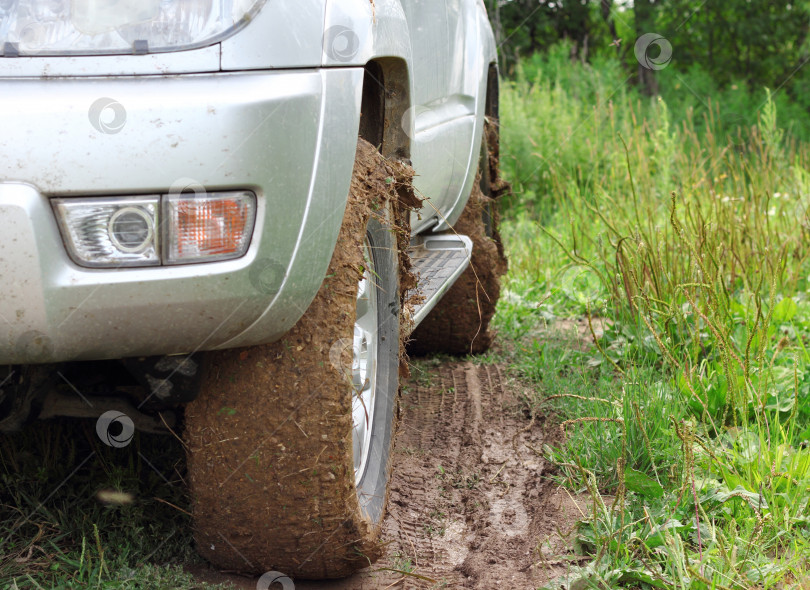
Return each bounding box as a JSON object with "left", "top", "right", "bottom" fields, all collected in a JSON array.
[{"left": 189, "top": 361, "right": 585, "bottom": 590}]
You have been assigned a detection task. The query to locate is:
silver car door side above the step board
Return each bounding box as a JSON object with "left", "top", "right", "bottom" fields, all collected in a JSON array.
[{"left": 402, "top": 0, "right": 475, "bottom": 231}]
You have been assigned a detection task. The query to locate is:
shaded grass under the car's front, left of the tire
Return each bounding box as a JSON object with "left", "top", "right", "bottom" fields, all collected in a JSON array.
[{"left": 0, "top": 419, "right": 230, "bottom": 590}]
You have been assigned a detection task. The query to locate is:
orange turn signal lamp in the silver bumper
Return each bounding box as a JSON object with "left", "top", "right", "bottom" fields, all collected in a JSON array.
[{"left": 163, "top": 191, "right": 256, "bottom": 264}]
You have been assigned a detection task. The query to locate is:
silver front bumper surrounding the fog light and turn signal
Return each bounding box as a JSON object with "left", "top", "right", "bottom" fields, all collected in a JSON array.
[{"left": 0, "top": 68, "right": 363, "bottom": 364}]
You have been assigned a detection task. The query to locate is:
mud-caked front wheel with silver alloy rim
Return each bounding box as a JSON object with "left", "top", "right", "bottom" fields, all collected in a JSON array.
[{"left": 186, "top": 141, "right": 403, "bottom": 578}]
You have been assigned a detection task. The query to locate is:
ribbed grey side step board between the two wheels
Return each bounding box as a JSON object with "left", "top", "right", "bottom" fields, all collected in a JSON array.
[{"left": 408, "top": 234, "right": 472, "bottom": 328}]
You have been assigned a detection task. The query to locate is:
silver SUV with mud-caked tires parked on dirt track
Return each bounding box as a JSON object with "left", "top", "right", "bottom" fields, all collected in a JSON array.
[{"left": 0, "top": 0, "right": 505, "bottom": 578}]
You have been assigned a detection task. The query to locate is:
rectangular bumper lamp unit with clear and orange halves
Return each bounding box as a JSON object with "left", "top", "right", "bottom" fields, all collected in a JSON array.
[{"left": 53, "top": 191, "right": 256, "bottom": 268}]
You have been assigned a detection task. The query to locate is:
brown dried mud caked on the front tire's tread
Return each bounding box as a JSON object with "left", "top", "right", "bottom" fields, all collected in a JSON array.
[{"left": 185, "top": 140, "right": 414, "bottom": 577}]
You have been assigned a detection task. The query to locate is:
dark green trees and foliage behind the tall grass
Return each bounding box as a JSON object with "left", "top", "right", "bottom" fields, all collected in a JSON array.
[{"left": 485, "top": 0, "right": 810, "bottom": 139}]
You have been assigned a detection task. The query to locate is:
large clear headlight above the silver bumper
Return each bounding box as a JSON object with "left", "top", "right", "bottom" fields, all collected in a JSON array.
[{"left": 0, "top": 0, "right": 265, "bottom": 55}]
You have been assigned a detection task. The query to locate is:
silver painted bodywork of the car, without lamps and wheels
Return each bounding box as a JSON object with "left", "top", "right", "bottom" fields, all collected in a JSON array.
[{"left": 0, "top": 0, "right": 495, "bottom": 364}]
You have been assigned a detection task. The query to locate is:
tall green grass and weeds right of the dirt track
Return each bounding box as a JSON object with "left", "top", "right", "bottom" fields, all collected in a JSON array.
[{"left": 496, "top": 51, "right": 810, "bottom": 589}]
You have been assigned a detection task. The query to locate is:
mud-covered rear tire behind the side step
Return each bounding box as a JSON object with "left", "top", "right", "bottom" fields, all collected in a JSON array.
[{"left": 408, "top": 124, "right": 509, "bottom": 356}]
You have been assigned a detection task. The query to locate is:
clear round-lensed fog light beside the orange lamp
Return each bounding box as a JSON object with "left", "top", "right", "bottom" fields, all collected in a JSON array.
[{"left": 53, "top": 196, "right": 160, "bottom": 267}]
